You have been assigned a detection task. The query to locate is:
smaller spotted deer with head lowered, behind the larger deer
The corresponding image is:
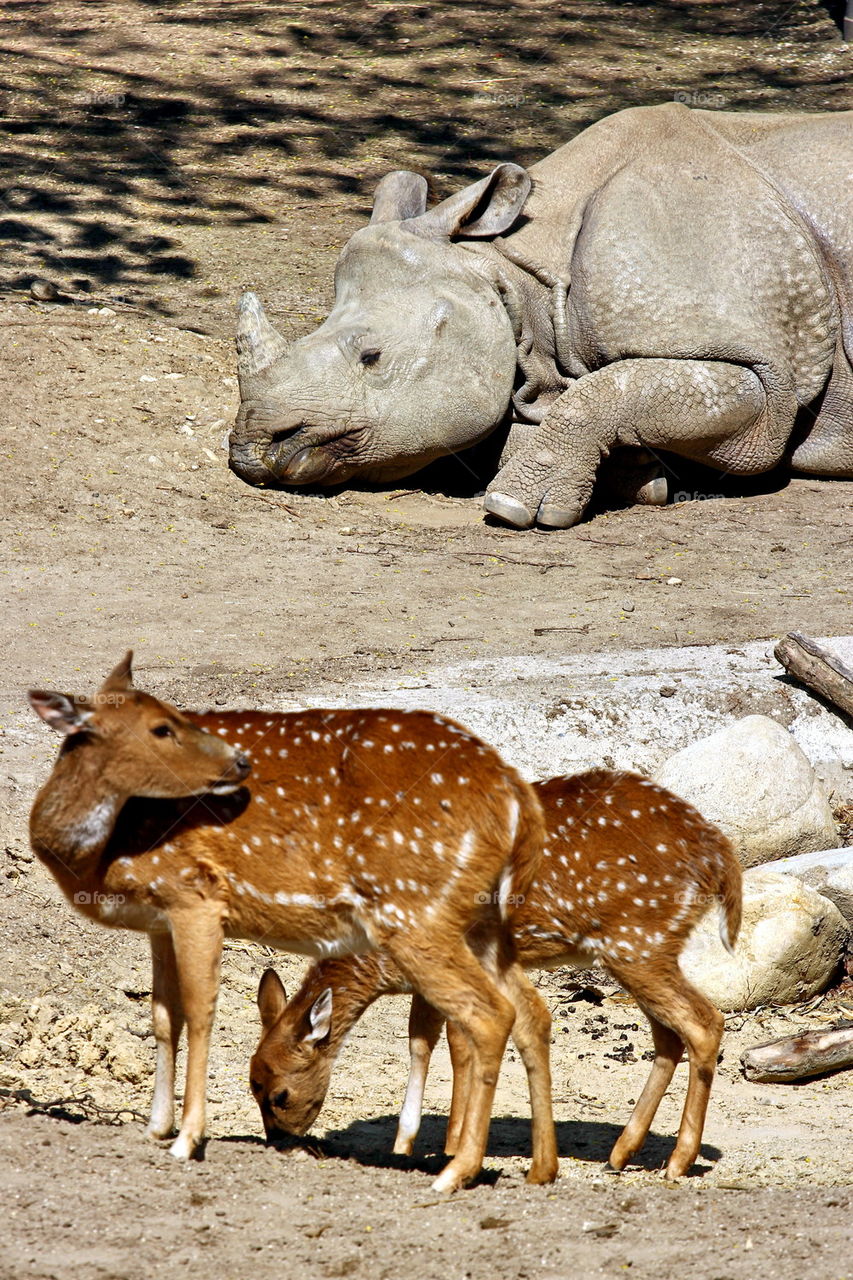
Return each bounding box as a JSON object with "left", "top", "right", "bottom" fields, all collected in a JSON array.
[{"left": 251, "top": 769, "right": 740, "bottom": 1178}]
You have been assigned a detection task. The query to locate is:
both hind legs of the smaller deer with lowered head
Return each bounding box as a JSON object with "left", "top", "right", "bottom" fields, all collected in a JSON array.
[{"left": 610, "top": 963, "right": 724, "bottom": 1178}]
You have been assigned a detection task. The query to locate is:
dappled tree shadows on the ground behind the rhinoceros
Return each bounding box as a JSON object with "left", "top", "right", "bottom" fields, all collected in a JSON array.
[{"left": 0, "top": 0, "right": 848, "bottom": 314}]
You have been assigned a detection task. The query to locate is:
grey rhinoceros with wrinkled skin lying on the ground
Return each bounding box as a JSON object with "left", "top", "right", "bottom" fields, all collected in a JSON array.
[{"left": 225, "top": 104, "right": 853, "bottom": 527}]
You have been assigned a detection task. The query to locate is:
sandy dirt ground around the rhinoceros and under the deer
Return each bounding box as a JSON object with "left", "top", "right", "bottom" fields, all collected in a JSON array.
[{"left": 0, "top": 0, "right": 853, "bottom": 1280}]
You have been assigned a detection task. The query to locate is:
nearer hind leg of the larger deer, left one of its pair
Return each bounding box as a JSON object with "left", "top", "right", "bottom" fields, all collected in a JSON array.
[{"left": 388, "top": 933, "right": 515, "bottom": 1192}]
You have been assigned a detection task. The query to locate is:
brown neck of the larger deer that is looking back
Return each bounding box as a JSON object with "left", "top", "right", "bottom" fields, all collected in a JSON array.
[{"left": 29, "top": 742, "right": 127, "bottom": 887}]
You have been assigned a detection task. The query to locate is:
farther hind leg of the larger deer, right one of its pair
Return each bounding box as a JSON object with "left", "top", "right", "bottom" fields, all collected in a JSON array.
[{"left": 484, "top": 957, "right": 558, "bottom": 1183}]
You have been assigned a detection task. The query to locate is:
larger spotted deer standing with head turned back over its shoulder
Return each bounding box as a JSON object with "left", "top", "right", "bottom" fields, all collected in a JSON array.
[{"left": 29, "top": 654, "right": 557, "bottom": 1190}]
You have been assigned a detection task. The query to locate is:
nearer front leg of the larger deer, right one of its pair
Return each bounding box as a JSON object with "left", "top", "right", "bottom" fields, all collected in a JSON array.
[{"left": 169, "top": 904, "right": 223, "bottom": 1160}]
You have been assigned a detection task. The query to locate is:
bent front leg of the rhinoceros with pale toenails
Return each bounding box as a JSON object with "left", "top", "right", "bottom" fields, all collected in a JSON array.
[{"left": 484, "top": 360, "right": 768, "bottom": 529}]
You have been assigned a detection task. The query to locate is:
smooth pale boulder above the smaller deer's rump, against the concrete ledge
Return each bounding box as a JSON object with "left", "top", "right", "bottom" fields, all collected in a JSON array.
[{"left": 656, "top": 716, "right": 838, "bottom": 867}]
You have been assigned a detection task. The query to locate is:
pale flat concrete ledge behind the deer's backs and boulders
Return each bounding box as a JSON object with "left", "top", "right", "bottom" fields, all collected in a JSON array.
[{"left": 292, "top": 636, "right": 853, "bottom": 799}]
